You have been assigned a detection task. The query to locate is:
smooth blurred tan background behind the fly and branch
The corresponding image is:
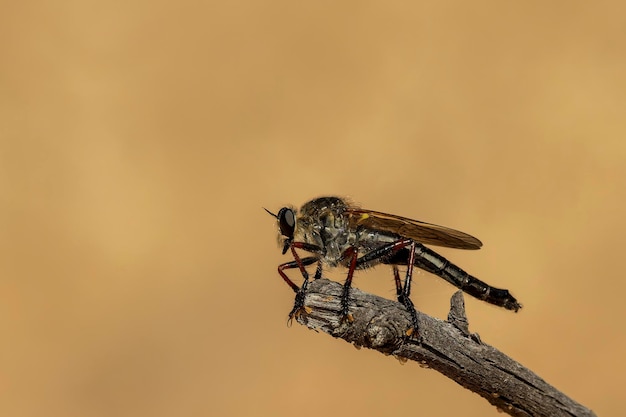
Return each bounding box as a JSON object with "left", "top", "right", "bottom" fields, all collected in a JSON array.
[{"left": 0, "top": 1, "right": 626, "bottom": 417}]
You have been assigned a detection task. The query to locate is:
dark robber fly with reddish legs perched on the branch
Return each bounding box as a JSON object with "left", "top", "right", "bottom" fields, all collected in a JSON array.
[{"left": 265, "top": 197, "right": 522, "bottom": 334}]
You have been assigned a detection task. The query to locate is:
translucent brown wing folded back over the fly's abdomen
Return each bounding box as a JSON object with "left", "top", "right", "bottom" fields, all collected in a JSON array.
[{"left": 347, "top": 208, "right": 483, "bottom": 249}]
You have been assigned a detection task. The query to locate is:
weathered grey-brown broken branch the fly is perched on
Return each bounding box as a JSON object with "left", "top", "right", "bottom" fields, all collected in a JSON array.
[{"left": 296, "top": 279, "right": 595, "bottom": 417}]
